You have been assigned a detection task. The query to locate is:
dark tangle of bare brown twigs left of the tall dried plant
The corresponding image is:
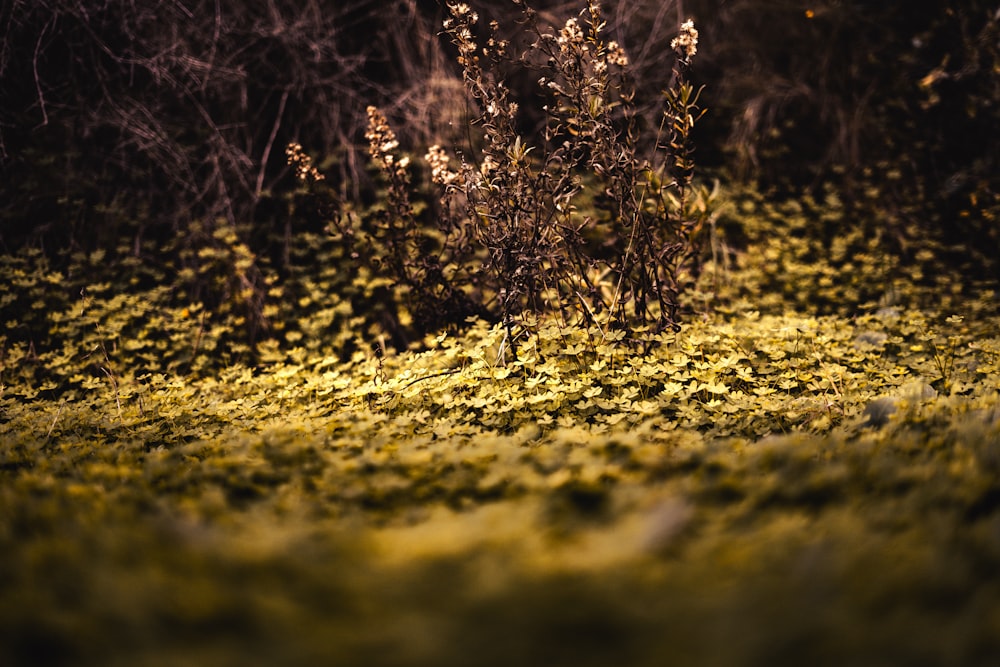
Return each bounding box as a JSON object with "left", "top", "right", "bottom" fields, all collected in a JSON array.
[{"left": 0, "top": 0, "right": 454, "bottom": 354}]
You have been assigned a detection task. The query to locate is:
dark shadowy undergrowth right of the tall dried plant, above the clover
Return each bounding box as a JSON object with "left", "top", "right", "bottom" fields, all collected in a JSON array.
[{"left": 693, "top": 0, "right": 1000, "bottom": 280}]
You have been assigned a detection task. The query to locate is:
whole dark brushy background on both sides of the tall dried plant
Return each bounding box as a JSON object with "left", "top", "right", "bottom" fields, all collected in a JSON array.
[{"left": 0, "top": 0, "right": 1000, "bottom": 340}]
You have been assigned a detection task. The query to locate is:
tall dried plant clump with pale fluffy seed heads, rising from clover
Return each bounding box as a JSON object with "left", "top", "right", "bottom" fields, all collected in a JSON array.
[{"left": 290, "top": 2, "right": 707, "bottom": 352}]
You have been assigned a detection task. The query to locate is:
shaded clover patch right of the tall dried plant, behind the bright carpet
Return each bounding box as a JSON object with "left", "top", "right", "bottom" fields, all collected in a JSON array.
[{"left": 691, "top": 186, "right": 996, "bottom": 316}]
